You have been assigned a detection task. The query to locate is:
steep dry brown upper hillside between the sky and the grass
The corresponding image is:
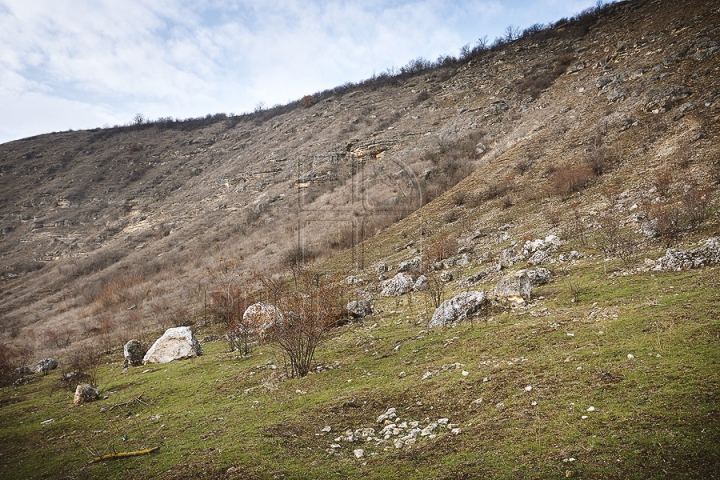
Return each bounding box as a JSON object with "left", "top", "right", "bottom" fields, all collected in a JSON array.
[{"left": 0, "top": 2, "right": 718, "bottom": 358}]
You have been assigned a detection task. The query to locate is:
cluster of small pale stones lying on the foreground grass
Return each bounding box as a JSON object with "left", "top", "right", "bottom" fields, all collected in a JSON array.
[{"left": 322, "top": 407, "right": 462, "bottom": 458}]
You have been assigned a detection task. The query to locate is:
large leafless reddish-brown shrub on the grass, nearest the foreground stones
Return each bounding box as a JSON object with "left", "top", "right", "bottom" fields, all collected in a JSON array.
[{"left": 270, "top": 268, "right": 347, "bottom": 377}]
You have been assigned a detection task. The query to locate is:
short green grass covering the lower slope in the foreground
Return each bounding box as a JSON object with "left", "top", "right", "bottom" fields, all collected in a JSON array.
[{"left": 0, "top": 260, "right": 720, "bottom": 479}]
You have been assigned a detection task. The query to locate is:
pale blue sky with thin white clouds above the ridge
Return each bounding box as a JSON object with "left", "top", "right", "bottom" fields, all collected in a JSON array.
[{"left": 0, "top": 0, "right": 596, "bottom": 143}]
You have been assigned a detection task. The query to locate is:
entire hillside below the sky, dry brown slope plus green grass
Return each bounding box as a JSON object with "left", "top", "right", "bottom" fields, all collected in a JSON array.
[{"left": 0, "top": 0, "right": 720, "bottom": 478}]
